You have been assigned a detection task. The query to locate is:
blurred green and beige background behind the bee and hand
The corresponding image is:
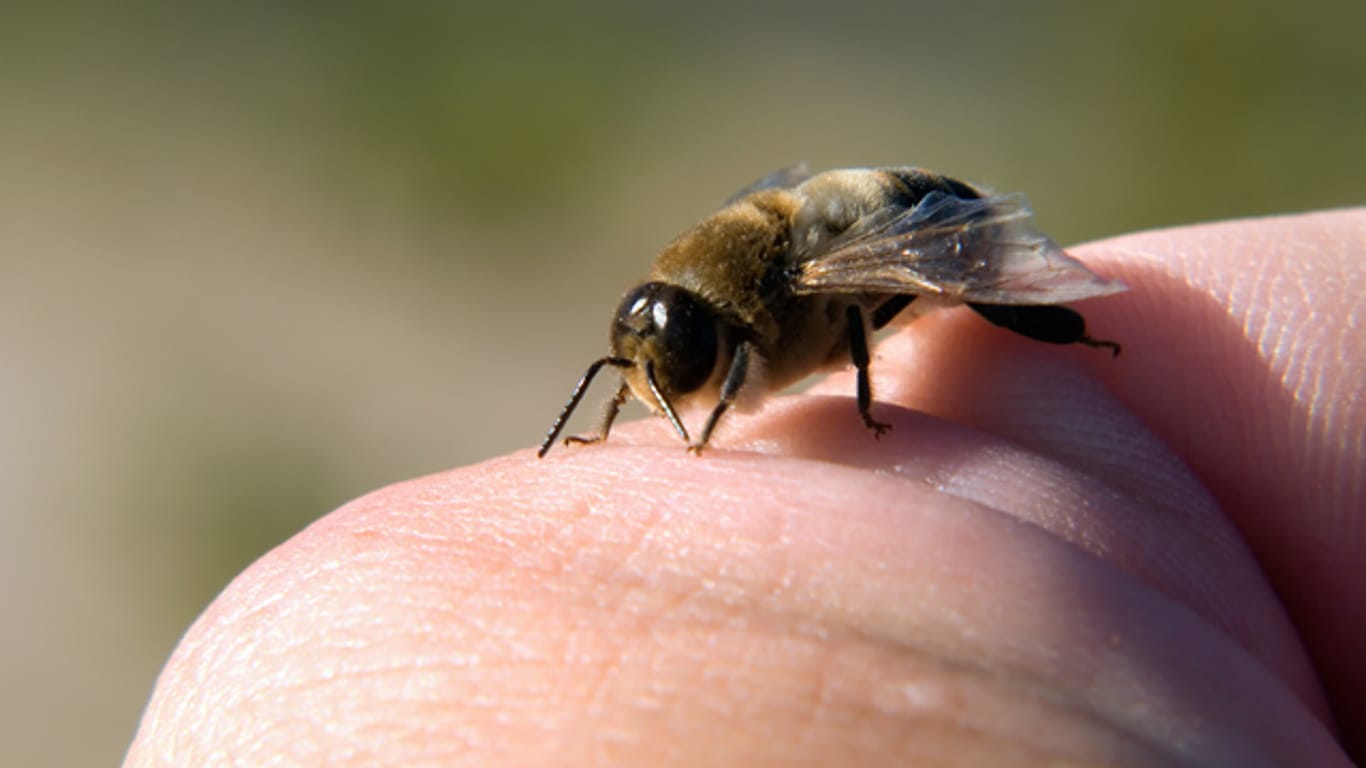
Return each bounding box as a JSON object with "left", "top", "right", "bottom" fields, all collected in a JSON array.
[{"left": 0, "top": 0, "right": 1366, "bottom": 767}]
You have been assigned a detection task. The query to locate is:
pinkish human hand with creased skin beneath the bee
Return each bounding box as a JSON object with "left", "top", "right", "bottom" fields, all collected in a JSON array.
[{"left": 126, "top": 209, "right": 1366, "bottom": 767}]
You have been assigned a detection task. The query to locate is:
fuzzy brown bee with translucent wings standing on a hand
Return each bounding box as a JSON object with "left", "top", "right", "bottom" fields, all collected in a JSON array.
[{"left": 537, "top": 165, "right": 1126, "bottom": 456}]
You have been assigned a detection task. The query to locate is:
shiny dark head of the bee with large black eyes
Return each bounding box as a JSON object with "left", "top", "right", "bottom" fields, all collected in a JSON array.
[{"left": 612, "top": 282, "right": 719, "bottom": 402}]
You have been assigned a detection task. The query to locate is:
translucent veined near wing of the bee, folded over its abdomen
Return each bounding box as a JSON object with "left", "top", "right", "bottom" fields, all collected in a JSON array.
[{"left": 792, "top": 191, "right": 1126, "bottom": 306}]
